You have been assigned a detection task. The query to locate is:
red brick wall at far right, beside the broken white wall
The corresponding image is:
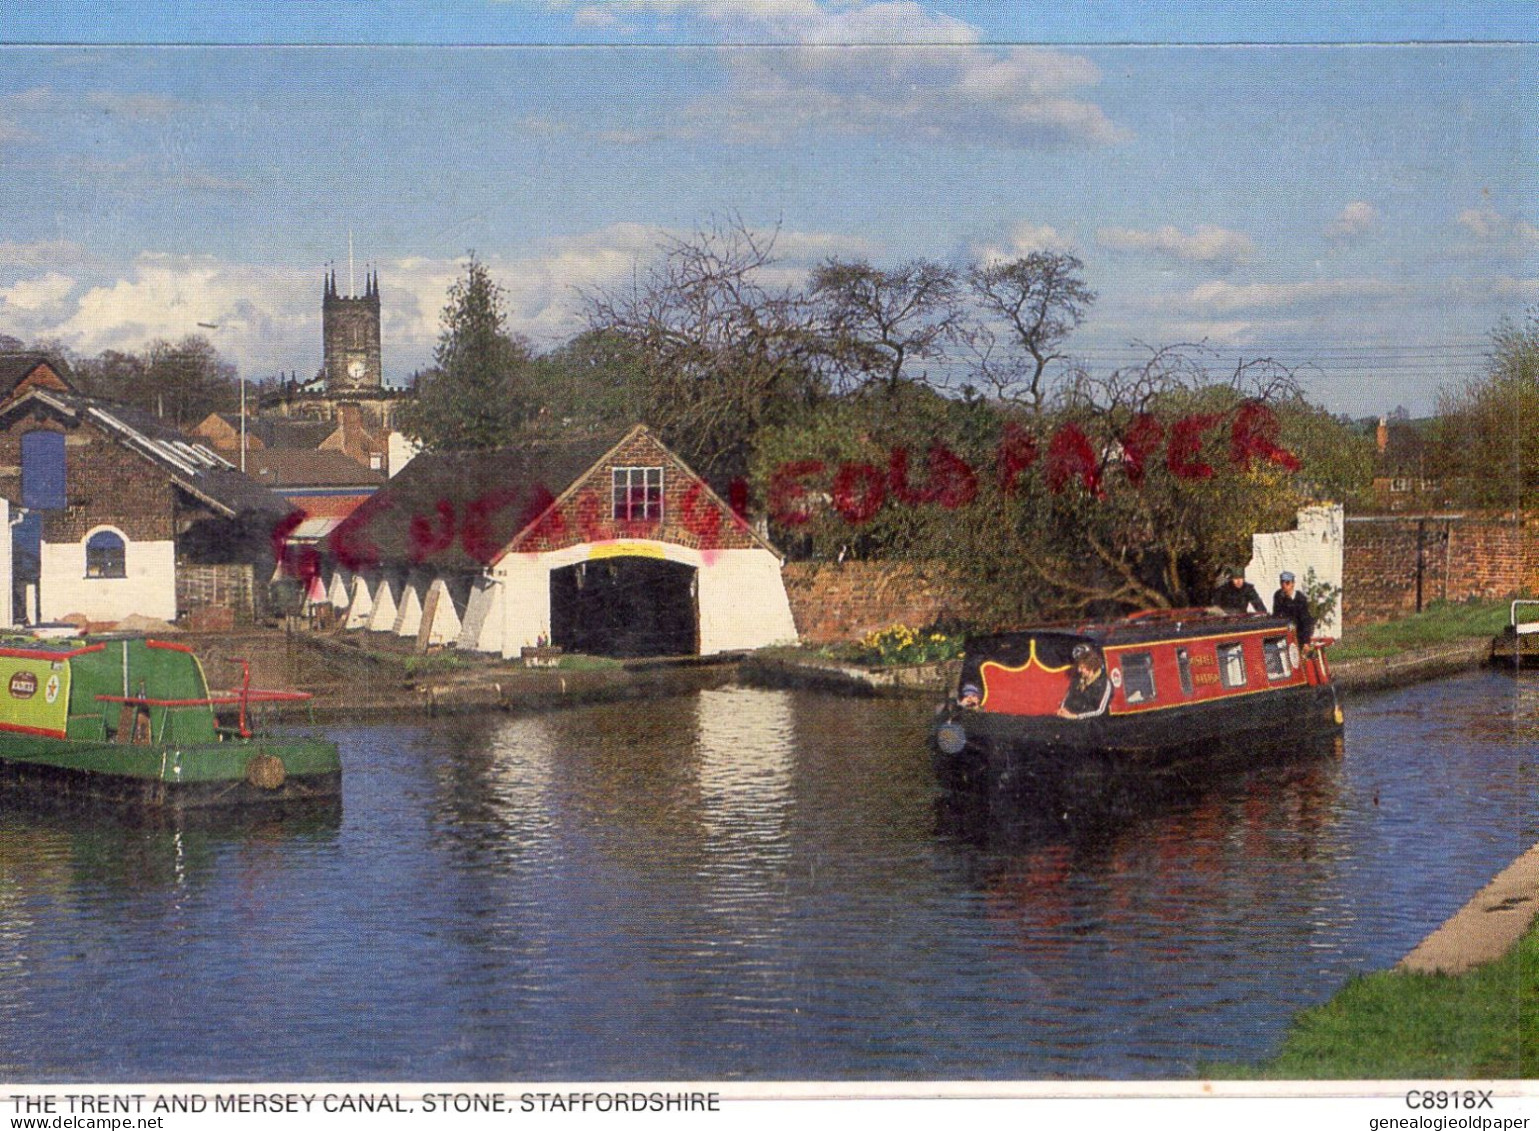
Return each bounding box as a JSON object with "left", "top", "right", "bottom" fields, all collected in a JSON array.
[{"left": 1342, "top": 514, "right": 1539, "bottom": 625}]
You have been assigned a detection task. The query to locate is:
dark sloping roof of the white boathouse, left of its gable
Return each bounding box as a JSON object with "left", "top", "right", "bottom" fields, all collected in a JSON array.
[{"left": 328, "top": 432, "right": 626, "bottom": 572}]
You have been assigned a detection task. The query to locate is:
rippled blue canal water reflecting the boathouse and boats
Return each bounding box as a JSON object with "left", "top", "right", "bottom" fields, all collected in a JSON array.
[{"left": 0, "top": 672, "right": 1539, "bottom": 1082}]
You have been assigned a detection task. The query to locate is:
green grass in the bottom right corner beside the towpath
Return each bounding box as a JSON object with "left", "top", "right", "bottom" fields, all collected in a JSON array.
[{"left": 1202, "top": 926, "right": 1539, "bottom": 1080}]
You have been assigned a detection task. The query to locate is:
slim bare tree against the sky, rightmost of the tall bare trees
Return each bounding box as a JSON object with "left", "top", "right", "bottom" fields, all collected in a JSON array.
[{"left": 966, "top": 251, "right": 1096, "bottom": 412}]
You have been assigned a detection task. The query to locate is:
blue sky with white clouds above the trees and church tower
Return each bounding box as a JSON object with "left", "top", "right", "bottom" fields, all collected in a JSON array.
[{"left": 0, "top": 0, "right": 1539, "bottom": 415}]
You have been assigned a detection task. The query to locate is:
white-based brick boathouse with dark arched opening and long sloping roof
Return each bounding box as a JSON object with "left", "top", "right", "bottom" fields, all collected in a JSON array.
[{"left": 326, "top": 425, "right": 796, "bottom": 657}]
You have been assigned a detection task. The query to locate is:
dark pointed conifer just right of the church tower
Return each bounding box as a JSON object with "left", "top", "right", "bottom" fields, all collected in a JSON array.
[{"left": 399, "top": 255, "right": 537, "bottom": 451}]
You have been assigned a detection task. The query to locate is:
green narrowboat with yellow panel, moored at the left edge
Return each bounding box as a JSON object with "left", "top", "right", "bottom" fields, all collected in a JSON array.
[{"left": 0, "top": 636, "right": 342, "bottom": 809}]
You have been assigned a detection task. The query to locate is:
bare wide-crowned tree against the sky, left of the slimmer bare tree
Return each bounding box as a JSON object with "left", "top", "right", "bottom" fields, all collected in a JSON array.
[{"left": 808, "top": 259, "right": 963, "bottom": 392}]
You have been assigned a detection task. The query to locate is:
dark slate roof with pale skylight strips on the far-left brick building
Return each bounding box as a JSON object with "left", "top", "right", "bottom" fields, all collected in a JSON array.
[{"left": 0, "top": 389, "right": 294, "bottom": 519}]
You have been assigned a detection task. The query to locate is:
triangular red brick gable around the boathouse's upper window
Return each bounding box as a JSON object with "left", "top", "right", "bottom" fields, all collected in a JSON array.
[{"left": 512, "top": 431, "right": 762, "bottom": 552}]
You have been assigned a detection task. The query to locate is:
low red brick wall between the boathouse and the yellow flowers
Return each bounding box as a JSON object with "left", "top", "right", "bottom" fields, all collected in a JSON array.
[{"left": 780, "top": 562, "right": 963, "bottom": 645}]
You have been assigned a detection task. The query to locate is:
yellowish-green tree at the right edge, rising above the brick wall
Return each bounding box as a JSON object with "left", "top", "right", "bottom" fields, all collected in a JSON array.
[{"left": 1433, "top": 309, "right": 1539, "bottom": 506}]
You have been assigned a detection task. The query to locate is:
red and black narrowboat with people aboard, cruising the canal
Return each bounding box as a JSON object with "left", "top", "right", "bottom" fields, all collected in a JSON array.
[{"left": 931, "top": 609, "right": 1342, "bottom": 803}]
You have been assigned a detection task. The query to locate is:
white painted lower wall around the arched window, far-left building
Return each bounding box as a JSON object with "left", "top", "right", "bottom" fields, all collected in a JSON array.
[{"left": 40, "top": 526, "right": 177, "bottom": 620}]
